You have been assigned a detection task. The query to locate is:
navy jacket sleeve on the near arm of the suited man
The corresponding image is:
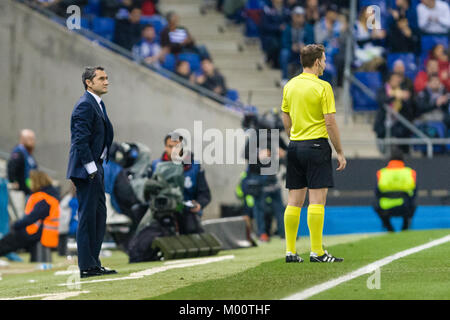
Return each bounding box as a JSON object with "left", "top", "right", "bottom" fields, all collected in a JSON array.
[{"left": 72, "top": 103, "right": 94, "bottom": 165}]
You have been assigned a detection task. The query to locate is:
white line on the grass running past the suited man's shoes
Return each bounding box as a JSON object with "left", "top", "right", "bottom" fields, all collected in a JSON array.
[{"left": 58, "top": 255, "right": 234, "bottom": 286}]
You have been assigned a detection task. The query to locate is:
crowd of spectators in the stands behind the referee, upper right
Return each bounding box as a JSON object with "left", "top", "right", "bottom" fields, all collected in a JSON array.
[{"left": 218, "top": 0, "right": 450, "bottom": 151}]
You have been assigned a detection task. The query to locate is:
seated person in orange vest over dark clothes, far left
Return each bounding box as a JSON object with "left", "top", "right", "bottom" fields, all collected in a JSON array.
[{"left": 0, "top": 170, "right": 59, "bottom": 256}]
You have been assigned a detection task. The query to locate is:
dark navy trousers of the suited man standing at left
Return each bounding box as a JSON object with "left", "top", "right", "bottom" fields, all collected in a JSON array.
[{"left": 72, "top": 163, "right": 106, "bottom": 270}]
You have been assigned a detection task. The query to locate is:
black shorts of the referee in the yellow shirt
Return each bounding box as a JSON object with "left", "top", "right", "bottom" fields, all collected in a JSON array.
[{"left": 286, "top": 138, "right": 334, "bottom": 189}]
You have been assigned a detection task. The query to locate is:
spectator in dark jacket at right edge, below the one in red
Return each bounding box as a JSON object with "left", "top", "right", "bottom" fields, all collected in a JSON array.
[{"left": 416, "top": 74, "right": 449, "bottom": 121}]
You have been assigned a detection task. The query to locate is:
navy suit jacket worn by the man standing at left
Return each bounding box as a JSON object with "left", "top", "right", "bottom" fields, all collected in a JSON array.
[{"left": 67, "top": 91, "right": 114, "bottom": 179}]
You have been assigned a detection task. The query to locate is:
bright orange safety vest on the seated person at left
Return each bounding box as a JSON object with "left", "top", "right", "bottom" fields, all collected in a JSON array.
[{"left": 25, "top": 192, "right": 59, "bottom": 248}]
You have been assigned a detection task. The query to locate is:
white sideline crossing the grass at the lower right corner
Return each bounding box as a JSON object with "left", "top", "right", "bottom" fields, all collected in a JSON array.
[{"left": 283, "top": 235, "right": 450, "bottom": 300}]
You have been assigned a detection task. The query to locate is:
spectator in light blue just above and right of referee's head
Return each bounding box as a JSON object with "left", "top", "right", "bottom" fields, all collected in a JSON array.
[{"left": 314, "top": 4, "right": 342, "bottom": 62}]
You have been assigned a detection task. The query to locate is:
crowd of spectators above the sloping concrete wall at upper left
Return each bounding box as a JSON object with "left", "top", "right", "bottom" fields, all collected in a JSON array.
[{"left": 30, "top": 0, "right": 238, "bottom": 100}]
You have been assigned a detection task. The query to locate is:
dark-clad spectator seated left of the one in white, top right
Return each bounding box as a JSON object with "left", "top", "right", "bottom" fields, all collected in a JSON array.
[{"left": 386, "top": 15, "right": 419, "bottom": 53}]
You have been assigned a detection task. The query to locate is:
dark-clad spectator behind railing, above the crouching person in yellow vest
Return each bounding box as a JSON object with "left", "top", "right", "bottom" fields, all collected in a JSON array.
[{"left": 374, "top": 73, "right": 415, "bottom": 152}]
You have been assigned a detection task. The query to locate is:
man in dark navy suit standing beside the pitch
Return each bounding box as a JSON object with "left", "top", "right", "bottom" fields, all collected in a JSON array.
[{"left": 67, "top": 67, "right": 117, "bottom": 278}]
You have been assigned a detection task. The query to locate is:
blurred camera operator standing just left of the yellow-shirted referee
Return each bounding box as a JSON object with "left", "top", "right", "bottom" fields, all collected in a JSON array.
[{"left": 242, "top": 110, "right": 287, "bottom": 242}]
